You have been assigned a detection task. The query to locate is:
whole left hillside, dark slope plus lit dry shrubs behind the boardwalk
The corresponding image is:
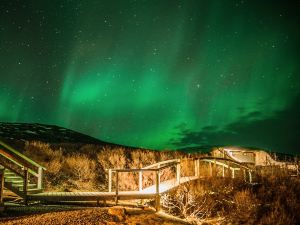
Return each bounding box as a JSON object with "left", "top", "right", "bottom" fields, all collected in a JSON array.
[{"left": 0, "top": 123, "right": 190, "bottom": 191}]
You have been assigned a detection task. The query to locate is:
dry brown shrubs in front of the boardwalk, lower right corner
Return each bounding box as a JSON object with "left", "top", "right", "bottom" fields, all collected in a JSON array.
[{"left": 163, "top": 172, "right": 300, "bottom": 225}]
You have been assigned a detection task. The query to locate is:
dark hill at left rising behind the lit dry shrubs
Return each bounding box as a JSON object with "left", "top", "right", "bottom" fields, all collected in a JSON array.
[{"left": 0, "top": 122, "right": 144, "bottom": 152}]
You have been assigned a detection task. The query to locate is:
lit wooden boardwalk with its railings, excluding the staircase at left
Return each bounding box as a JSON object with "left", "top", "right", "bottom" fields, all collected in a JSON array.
[{"left": 27, "top": 157, "right": 252, "bottom": 210}]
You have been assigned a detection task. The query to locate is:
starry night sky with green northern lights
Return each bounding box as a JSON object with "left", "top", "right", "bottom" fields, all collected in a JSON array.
[{"left": 0, "top": 0, "right": 300, "bottom": 153}]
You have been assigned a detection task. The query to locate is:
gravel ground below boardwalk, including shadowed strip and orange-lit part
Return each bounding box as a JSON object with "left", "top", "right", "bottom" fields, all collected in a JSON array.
[{"left": 0, "top": 206, "right": 187, "bottom": 225}]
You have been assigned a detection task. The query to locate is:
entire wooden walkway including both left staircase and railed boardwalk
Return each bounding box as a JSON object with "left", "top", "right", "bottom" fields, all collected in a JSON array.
[{"left": 0, "top": 141, "right": 258, "bottom": 210}]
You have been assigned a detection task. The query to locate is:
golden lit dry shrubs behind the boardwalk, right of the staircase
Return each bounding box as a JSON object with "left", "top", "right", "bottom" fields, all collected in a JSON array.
[{"left": 24, "top": 141, "right": 185, "bottom": 191}]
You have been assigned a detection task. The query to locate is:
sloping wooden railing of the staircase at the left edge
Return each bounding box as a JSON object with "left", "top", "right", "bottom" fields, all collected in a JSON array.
[{"left": 0, "top": 140, "right": 46, "bottom": 195}]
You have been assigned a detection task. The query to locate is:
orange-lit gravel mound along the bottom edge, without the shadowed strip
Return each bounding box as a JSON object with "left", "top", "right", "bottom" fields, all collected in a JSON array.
[{"left": 0, "top": 208, "right": 187, "bottom": 225}]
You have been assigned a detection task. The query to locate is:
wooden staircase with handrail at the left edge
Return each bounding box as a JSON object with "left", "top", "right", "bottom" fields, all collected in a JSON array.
[{"left": 0, "top": 140, "right": 45, "bottom": 201}]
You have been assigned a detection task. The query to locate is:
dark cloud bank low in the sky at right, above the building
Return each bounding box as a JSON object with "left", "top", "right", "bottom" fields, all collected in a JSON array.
[{"left": 173, "top": 95, "right": 300, "bottom": 154}]
